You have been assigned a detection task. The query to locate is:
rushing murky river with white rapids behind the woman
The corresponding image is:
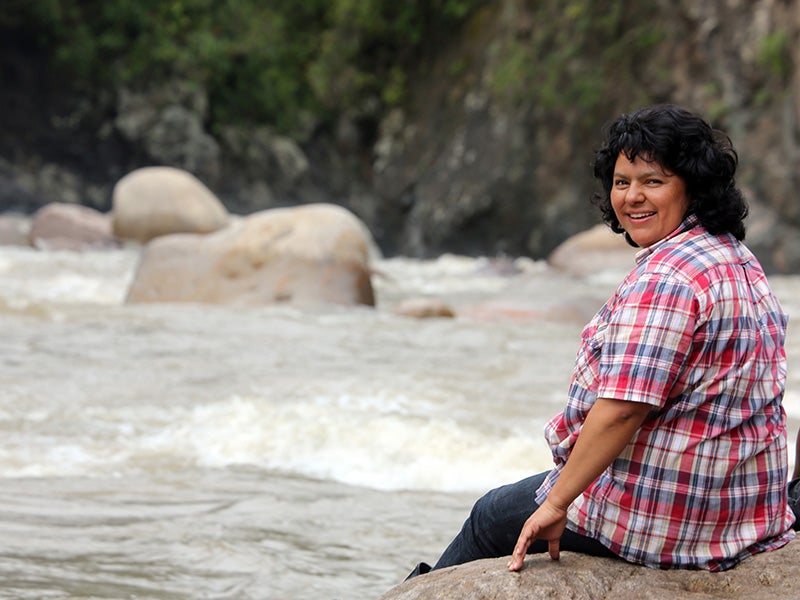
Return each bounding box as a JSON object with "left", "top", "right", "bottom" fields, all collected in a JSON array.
[{"left": 0, "top": 247, "right": 800, "bottom": 600}]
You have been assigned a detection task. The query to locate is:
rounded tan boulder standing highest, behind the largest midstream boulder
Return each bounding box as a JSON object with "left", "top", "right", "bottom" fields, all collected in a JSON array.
[{"left": 112, "top": 167, "right": 229, "bottom": 243}]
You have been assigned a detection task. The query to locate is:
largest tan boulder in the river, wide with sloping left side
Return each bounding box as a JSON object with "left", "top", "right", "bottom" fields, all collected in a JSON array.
[{"left": 128, "top": 204, "right": 375, "bottom": 306}]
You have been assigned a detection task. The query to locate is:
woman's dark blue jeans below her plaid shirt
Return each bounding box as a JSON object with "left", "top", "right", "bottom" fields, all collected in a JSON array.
[{"left": 433, "top": 472, "right": 616, "bottom": 569}]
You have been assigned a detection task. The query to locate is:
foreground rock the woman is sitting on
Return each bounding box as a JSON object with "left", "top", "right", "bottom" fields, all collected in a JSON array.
[{"left": 380, "top": 540, "right": 800, "bottom": 600}]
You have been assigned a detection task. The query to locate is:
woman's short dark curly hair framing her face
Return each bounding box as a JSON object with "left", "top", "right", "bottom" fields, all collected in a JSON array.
[{"left": 592, "top": 104, "right": 748, "bottom": 246}]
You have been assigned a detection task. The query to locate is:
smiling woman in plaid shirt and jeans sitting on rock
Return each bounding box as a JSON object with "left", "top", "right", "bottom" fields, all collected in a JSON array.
[{"left": 412, "top": 105, "right": 795, "bottom": 575}]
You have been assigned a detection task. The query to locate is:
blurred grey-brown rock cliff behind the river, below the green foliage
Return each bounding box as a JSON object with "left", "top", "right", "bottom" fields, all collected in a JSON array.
[{"left": 0, "top": 0, "right": 800, "bottom": 272}]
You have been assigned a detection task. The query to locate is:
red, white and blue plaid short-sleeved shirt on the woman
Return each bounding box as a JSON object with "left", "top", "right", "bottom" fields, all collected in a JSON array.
[{"left": 536, "top": 216, "right": 794, "bottom": 571}]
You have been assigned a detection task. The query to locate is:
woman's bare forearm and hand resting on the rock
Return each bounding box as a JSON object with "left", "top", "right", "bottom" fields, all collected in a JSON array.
[{"left": 508, "top": 398, "right": 653, "bottom": 571}]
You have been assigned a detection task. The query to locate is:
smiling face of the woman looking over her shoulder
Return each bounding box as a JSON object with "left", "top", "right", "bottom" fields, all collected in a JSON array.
[{"left": 611, "top": 152, "right": 689, "bottom": 248}]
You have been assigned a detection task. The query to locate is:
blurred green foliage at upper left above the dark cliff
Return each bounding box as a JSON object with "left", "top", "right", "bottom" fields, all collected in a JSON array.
[{"left": 0, "top": 0, "right": 486, "bottom": 131}]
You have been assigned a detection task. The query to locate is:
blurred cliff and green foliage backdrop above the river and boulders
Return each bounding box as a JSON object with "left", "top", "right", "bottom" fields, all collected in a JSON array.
[{"left": 0, "top": 0, "right": 800, "bottom": 273}]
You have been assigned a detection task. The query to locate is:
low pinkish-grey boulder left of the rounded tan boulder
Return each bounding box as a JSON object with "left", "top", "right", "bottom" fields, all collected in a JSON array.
[{"left": 29, "top": 202, "right": 119, "bottom": 250}]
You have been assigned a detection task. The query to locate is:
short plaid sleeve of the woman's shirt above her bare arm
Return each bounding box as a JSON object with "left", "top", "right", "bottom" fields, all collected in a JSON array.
[{"left": 597, "top": 274, "right": 698, "bottom": 407}]
